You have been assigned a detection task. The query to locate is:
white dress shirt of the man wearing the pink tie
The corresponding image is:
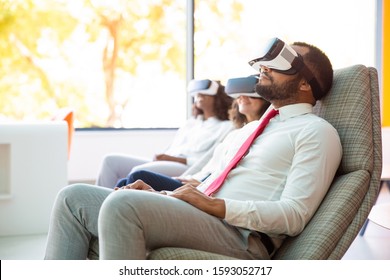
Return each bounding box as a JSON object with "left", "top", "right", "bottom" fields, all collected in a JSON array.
[{"left": 198, "top": 103, "right": 342, "bottom": 246}]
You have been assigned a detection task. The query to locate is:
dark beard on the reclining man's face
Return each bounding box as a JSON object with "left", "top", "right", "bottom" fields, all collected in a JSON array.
[{"left": 256, "top": 76, "right": 301, "bottom": 102}]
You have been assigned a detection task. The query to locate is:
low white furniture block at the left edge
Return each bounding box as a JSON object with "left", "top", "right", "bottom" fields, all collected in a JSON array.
[{"left": 0, "top": 121, "right": 68, "bottom": 237}]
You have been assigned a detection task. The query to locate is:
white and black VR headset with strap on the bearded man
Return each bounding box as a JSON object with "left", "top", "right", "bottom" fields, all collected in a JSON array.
[{"left": 248, "top": 38, "right": 323, "bottom": 100}]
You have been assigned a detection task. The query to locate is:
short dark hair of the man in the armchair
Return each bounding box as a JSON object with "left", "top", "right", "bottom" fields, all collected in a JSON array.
[{"left": 292, "top": 42, "right": 333, "bottom": 99}]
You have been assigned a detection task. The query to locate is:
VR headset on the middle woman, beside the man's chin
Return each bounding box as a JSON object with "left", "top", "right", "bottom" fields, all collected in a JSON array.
[{"left": 225, "top": 75, "right": 261, "bottom": 98}]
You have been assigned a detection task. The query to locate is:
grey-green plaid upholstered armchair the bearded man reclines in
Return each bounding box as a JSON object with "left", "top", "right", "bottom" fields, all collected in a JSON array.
[{"left": 148, "top": 65, "right": 382, "bottom": 260}]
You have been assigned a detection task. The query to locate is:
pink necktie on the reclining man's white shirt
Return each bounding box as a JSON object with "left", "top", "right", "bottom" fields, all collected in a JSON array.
[{"left": 204, "top": 109, "right": 279, "bottom": 195}]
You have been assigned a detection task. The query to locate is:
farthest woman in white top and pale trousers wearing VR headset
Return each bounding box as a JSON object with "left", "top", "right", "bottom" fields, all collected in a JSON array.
[{"left": 96, "top": 80, "right": 233, "bottom": 188}]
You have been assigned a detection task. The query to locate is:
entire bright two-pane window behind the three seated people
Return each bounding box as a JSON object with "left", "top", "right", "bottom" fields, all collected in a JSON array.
[{"left": 0, "top": 0, "right": 376, "bottom": 128}]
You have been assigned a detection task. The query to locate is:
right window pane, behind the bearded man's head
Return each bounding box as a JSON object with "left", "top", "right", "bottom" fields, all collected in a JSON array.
[{"left": 195, "top": 0, "right": 376, "bottom": 82}]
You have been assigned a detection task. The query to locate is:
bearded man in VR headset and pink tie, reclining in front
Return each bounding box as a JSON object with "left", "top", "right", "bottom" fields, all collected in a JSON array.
[{"left": 45, "top": 38, "right": 342, "bottom": 259}]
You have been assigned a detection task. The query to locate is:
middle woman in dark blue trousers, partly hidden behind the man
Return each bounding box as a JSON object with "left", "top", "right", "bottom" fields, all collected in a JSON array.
[{"left": 115, "top": 76, "right": 270, "bottom": 191}]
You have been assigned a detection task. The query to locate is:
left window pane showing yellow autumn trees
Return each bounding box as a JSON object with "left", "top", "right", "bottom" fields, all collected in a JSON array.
[{"left": 0, "top": 0, "right": 186, "bottom": 127}]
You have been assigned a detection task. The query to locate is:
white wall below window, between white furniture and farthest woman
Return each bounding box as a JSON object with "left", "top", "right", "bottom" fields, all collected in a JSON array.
[{"left": 68, "top": 129, "right": 176, "bottom": 182}]
